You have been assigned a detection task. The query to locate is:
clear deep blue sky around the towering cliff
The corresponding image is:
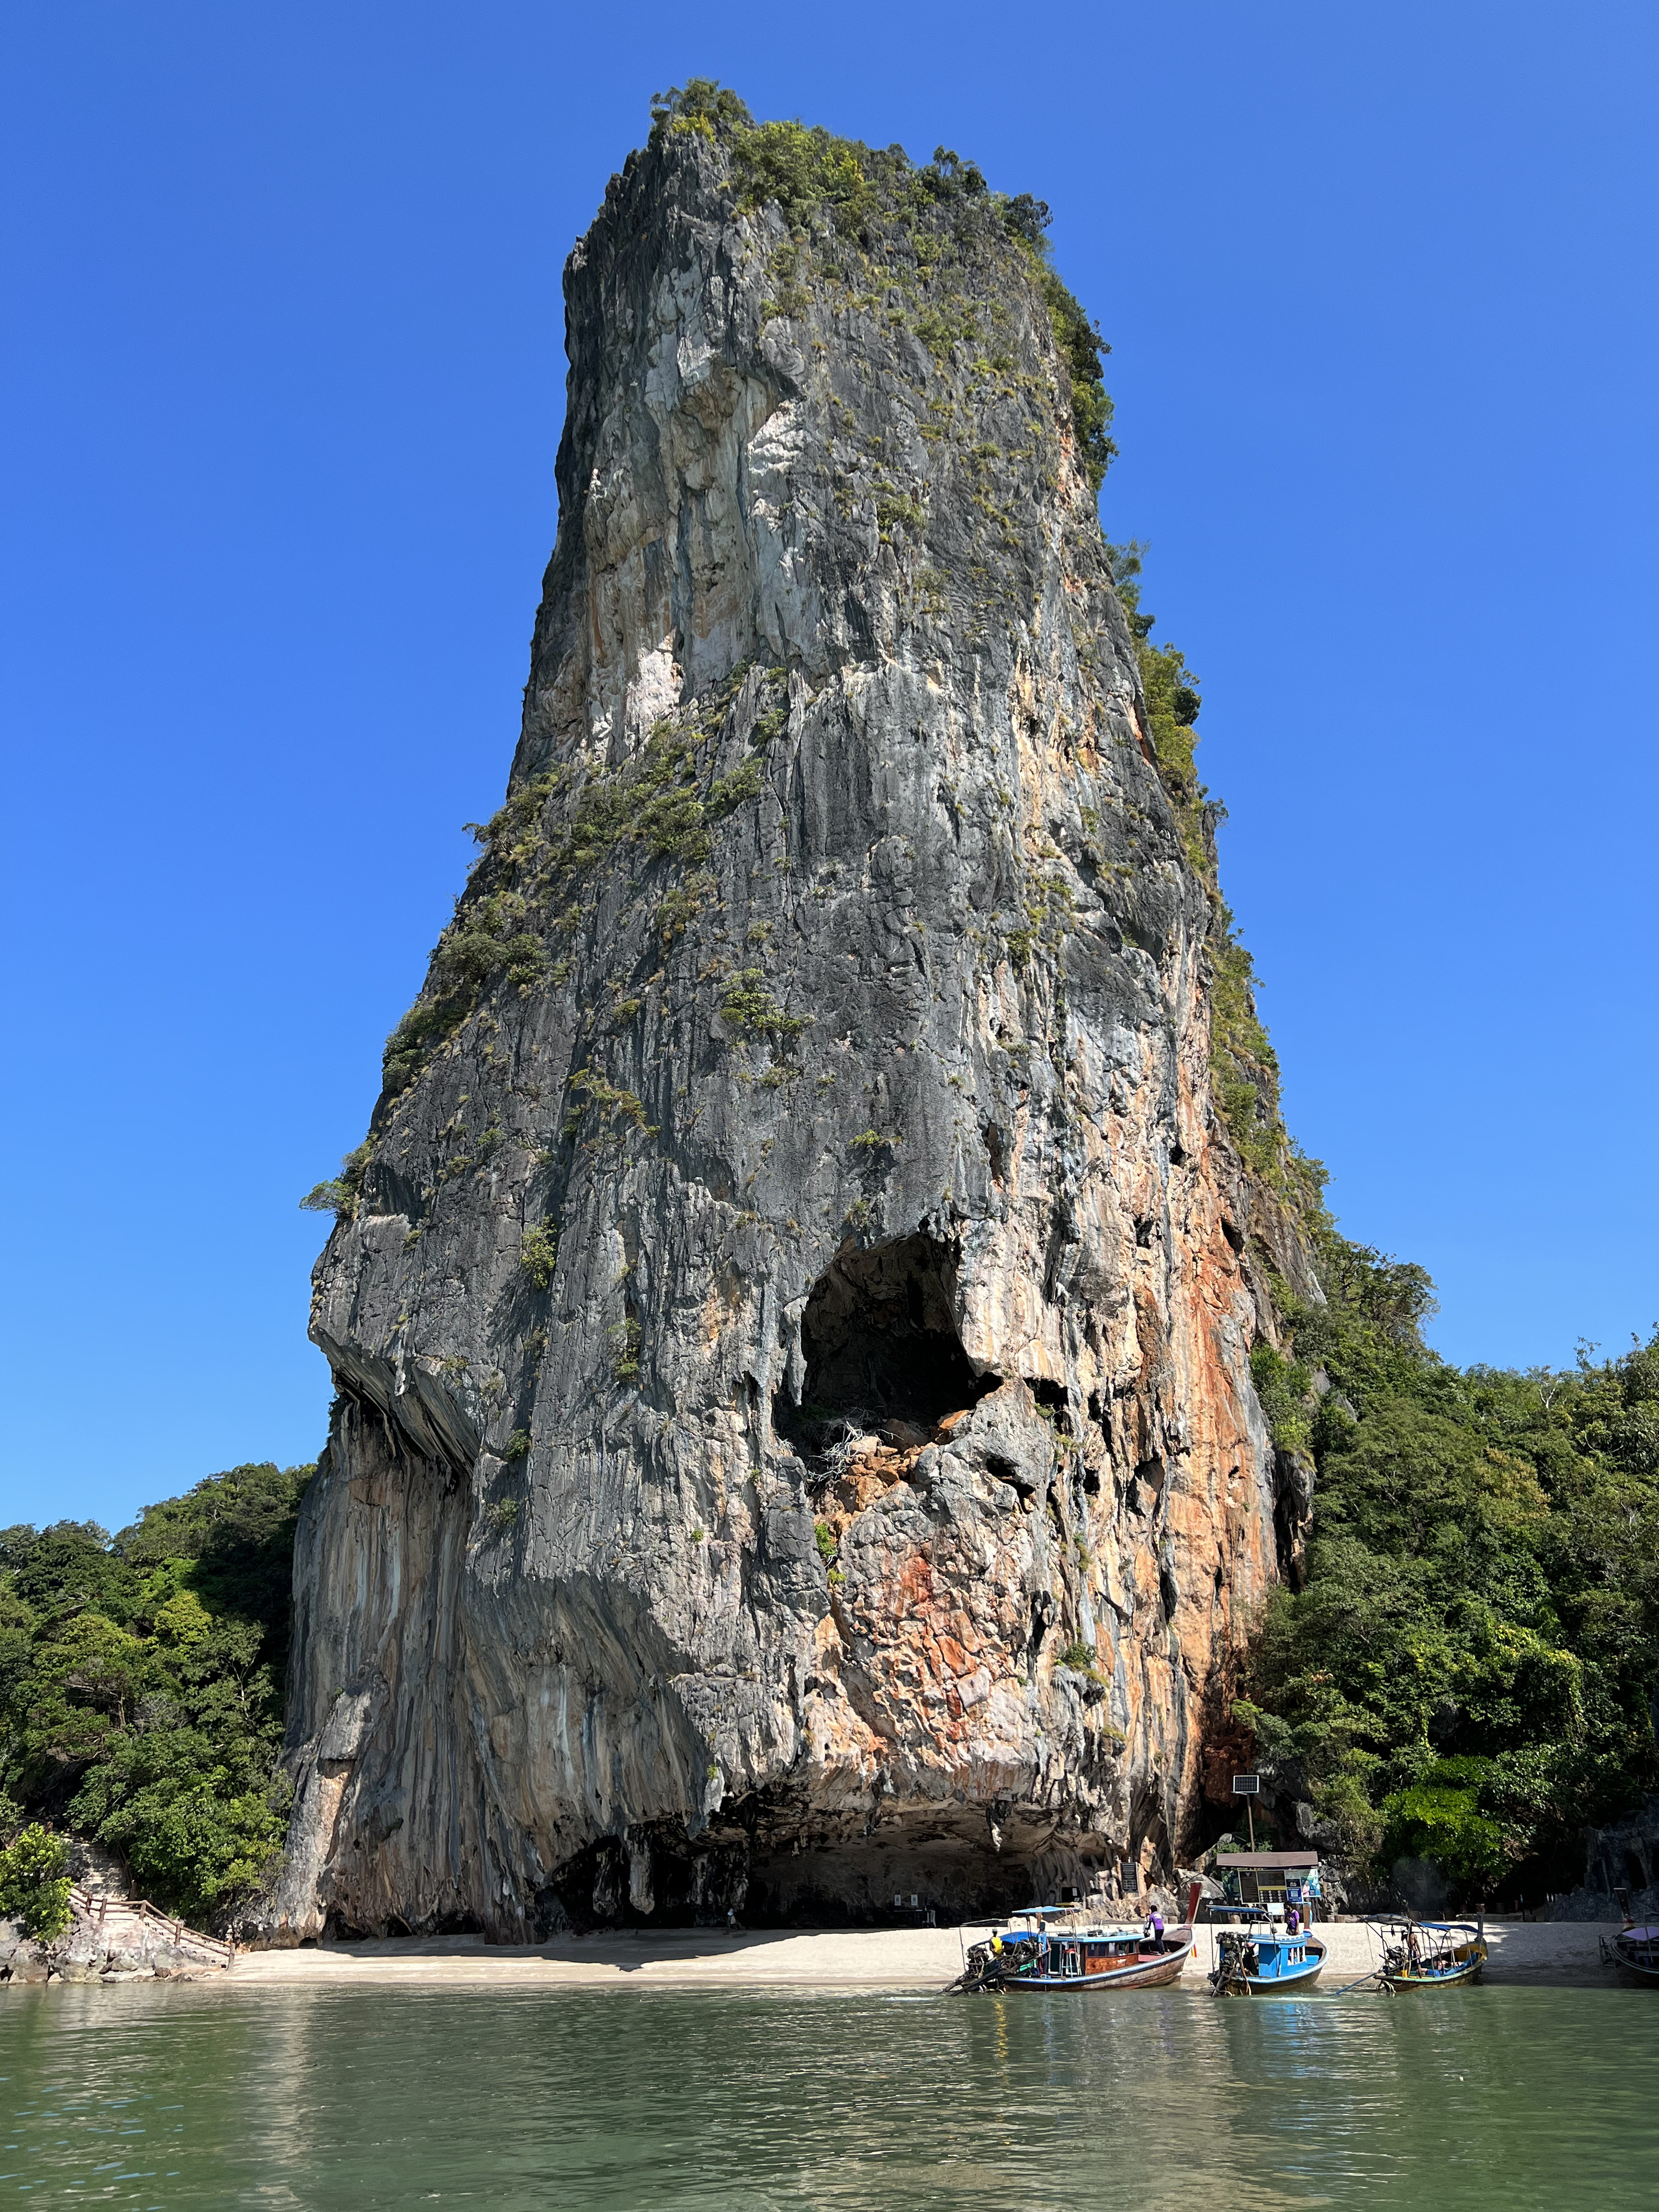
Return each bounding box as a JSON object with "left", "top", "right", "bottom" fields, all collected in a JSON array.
[{"left": 0, "top": 0, "right": 1659, "bottom": 1524}]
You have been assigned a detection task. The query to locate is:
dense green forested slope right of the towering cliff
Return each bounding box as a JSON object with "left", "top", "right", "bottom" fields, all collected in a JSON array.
[{"left": 1239, "top": 1225, "right": 1659, "bottom": 1898}]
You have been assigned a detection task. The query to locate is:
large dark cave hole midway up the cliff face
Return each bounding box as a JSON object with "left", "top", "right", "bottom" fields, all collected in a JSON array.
[{"left": 772, "top": 1237, "right": 1002, "bottom": 1451}]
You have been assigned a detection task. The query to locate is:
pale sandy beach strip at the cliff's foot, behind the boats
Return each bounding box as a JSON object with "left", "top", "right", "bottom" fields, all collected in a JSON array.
[{"left": 221, "top": 1920, "right": 1619, "bottom": 1995}]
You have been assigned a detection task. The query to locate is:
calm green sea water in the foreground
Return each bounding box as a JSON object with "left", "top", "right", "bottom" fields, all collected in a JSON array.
[{"left": 0, "top": 1984, "right": 1659, "bottom": 2212}]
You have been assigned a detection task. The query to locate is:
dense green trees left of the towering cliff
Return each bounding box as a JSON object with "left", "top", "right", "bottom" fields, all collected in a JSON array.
[{"left": 0, "top": 1464, "right": 312, "bottom": 1920}]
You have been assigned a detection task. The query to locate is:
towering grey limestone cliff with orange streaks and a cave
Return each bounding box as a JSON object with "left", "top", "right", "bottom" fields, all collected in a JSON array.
[{"left": 272, "top": 111, "right": 1312, "bottom": 1940}]
